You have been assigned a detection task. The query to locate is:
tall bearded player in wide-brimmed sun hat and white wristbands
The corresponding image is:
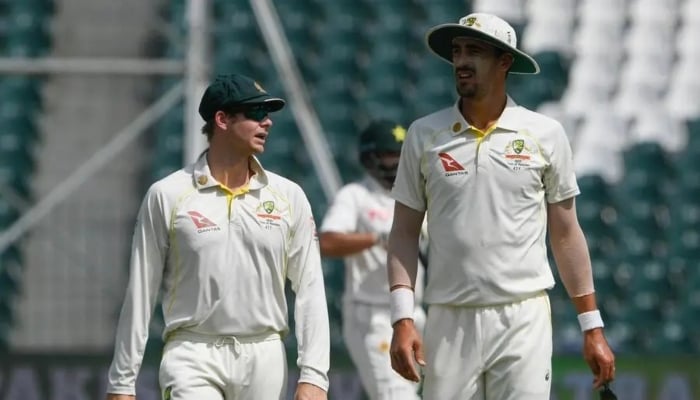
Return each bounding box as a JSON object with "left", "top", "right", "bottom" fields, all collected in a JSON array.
[{"left": 388, "top": 14, "right": 615, "bottom": 400}]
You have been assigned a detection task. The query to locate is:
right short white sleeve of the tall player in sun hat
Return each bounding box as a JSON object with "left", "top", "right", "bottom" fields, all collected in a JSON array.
[{"left": 544, "top": 123, "right": 580, "bottom": 203}]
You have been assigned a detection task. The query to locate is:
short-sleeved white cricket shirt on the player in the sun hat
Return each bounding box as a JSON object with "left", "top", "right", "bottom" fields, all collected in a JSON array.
[{"left": 392, "top": 98, "right": 579, "bottom": 306}]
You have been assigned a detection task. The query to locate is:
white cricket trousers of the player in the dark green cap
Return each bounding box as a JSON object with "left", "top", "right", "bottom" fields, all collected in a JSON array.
[{"left": 158, "top": 332, "right": 287, "bottom": 400}]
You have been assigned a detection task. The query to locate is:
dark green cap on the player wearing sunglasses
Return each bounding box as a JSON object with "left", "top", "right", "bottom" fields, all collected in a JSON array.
[{"left": 199, "top": 74, "right": 285, "bottom": 121}]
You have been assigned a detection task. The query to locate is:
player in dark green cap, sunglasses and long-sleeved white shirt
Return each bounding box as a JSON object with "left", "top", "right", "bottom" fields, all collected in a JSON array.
[{"left": 107, "top": 75, "right": 330, "bottom": 400}]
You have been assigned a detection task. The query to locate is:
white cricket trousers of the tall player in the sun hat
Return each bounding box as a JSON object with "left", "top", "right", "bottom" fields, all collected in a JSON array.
[{"left": 423, "top": 292, "right": 552, "bottom": 400}]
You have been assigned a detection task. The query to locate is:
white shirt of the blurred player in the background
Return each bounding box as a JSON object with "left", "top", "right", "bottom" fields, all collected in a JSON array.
[{"left": 321, "top": 176, "right": 424, "bottom": 307}]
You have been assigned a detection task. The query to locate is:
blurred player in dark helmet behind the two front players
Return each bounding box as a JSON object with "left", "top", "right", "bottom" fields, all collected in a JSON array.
[{"left": 320, "top": 120, "right": 424, "bottom": 400}]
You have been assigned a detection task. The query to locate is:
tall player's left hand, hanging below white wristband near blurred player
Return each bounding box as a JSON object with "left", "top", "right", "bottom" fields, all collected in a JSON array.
[{"left": 389, "top": 319, "right": 425, "bottom": 382}]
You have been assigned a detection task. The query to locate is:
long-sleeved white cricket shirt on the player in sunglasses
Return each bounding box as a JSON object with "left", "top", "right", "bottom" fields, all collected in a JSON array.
[{"left": 108, "top": 153, "right": 330, "bottom": 394}]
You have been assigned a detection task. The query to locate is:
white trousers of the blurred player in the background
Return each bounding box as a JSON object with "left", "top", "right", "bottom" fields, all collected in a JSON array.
[{"left": 343, "top": 300, "right": 425, "bottom": 400}]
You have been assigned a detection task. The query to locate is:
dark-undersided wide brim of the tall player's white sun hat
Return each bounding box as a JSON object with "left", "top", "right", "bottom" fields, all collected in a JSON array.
[{"left": 426, "top": 24, "right": 540, "bottom": 74}]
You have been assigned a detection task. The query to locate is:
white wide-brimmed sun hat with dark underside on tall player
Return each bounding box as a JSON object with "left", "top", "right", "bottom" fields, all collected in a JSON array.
[{"left": 426, "top": 13, "right": 540, "bottom": 74}]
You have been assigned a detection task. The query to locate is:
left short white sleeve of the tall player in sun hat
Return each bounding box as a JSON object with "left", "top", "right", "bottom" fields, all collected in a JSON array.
[{"left": 391, "top": 123, "right": 426, "bottom": 211}]
